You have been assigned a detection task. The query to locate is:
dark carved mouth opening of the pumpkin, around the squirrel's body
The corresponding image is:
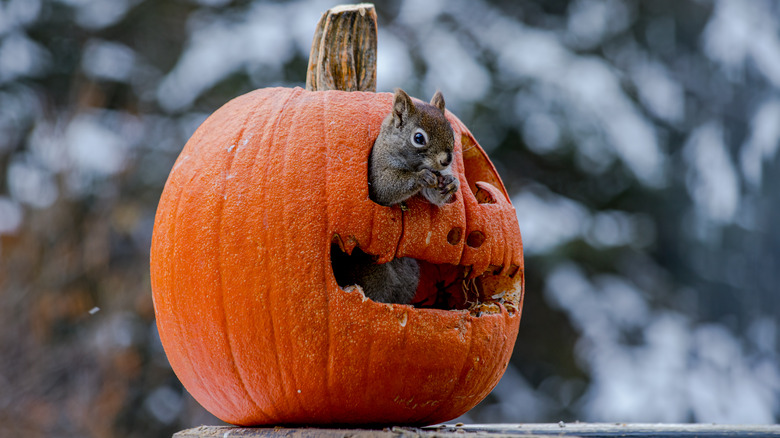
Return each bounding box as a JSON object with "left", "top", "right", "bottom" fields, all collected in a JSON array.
[{"left": 331, "top": 244, "right": 523, "bottom": 316}]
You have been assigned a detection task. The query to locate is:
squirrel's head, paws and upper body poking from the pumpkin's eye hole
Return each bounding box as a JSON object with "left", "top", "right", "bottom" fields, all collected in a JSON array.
[{"left": 368, "top": 88, "right": 459, "bottom": 208}]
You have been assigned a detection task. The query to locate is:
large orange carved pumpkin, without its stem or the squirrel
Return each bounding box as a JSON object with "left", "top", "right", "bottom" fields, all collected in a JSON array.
[{"left": 151, "top": 88, "right": 523, "bottom": 425}]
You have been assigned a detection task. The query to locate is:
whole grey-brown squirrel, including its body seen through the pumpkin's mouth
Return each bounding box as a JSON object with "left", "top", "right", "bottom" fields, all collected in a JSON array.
[{"left": 332, "top": 88, "right": 459, "bottom": 304}]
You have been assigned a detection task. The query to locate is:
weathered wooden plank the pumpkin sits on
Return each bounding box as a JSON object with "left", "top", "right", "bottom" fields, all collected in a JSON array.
[{"left": 174, "top": 423, "right": 780, "bottom": 438}]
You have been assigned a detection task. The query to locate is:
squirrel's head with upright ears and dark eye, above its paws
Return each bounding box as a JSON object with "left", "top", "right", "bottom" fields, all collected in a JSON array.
[{"left": 386, "top": 88, "right": 455, "bottom": 171}]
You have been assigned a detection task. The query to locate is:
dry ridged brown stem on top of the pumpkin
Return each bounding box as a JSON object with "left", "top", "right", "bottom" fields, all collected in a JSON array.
[{"left": 306, "top": 3, "right": 377, "bottom": 92}]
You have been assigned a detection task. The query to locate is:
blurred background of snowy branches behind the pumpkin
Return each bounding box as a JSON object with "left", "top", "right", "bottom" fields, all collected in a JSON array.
[{"left": 0, "top": 0, "right": 780, "bottom": 437}]
